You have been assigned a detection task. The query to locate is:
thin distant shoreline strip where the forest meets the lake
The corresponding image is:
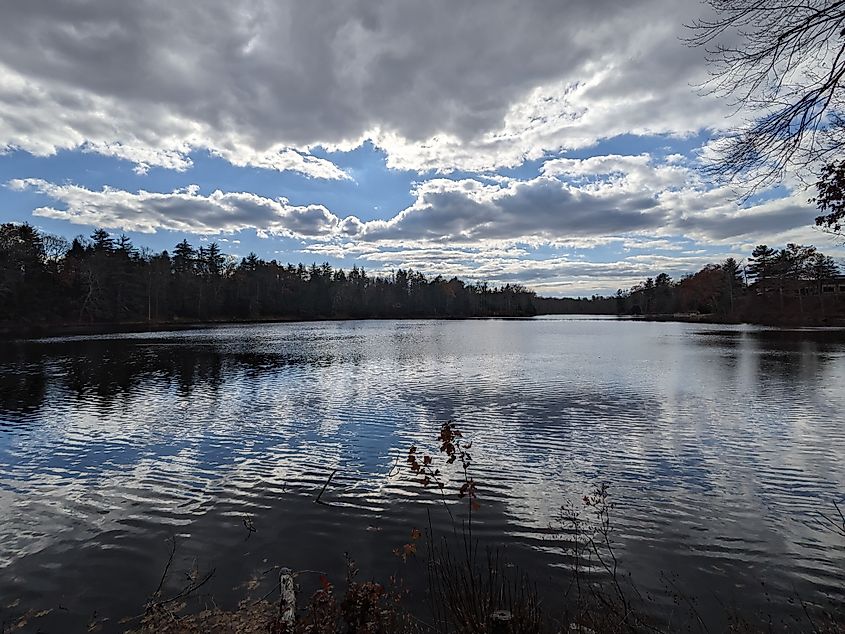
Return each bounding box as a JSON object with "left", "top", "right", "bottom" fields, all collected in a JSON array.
[{"left": 0, "top": 313, "right": 845, "bottom": 341}]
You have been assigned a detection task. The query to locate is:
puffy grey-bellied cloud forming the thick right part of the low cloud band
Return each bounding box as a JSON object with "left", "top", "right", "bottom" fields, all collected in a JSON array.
[{"left": 342, "top": 154, "right": 813, "bottom": 248}]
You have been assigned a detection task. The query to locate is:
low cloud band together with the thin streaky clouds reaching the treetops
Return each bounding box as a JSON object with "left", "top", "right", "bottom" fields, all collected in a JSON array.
[{"left": 14, "top": 146, "right": 837, "bottom": 294}]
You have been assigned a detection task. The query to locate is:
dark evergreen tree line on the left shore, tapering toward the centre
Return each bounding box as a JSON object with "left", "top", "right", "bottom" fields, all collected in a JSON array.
[{"left": 0, "top": 223, "right": 536, "bottom": 326}]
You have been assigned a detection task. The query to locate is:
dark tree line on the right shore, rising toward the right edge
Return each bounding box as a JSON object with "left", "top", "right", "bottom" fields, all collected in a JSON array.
[{"left": 536, "top": 244, "right": 845, "bottom": 323}]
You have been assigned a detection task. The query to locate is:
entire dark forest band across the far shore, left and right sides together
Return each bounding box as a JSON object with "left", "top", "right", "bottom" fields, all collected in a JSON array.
[{"left": 0, "top": 223, "right": 845, "bottom": 332}]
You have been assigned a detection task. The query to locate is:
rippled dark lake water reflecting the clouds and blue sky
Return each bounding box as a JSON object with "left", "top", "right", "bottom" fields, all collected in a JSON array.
[{"left": 0, "top": 317, "right": 845, "bottom": 631}]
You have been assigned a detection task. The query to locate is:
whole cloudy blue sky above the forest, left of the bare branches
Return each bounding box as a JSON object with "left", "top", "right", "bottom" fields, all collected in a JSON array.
[{"left": 0, "top": 0, "right": 845, "bottom": 296}]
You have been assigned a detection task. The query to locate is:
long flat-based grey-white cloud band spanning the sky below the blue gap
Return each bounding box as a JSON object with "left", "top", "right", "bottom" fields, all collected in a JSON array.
[{"left": 10, "top": 154, "right": 824, "bottom": 252}]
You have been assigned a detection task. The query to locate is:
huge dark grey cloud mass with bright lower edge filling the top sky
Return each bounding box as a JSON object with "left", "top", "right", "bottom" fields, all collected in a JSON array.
[{"left": 0, "top": 0, "right": 725, "bottom": 173}]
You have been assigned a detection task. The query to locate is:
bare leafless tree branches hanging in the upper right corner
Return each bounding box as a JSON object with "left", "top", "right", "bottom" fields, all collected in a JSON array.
[{"left": 686, "top": 0, "right": 845, "bottom": 193}]
